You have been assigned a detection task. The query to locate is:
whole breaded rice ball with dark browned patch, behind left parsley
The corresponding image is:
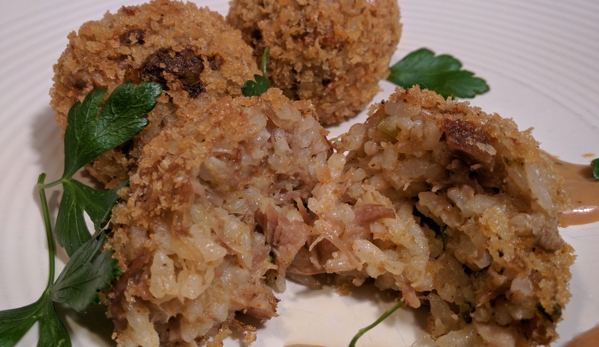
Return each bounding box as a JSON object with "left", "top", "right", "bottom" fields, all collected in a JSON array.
[{"left": 50, "top": 0, "right": 259, "bottom": 187}]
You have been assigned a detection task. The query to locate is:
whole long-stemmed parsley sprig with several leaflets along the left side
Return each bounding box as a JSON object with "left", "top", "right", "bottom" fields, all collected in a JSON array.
[{"left": 0, "top": 82, "right": 162, "bottom": 347}]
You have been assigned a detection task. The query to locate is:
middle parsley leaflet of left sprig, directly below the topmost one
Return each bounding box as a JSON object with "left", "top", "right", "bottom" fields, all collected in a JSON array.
[{"left": 54, "top": 178, "right": 127, "bottom": 256}]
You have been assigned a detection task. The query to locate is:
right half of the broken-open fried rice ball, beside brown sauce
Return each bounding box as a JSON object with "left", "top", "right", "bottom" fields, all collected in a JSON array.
[{"left": 287, "top": 87, "right": 574, "bottom": 347}]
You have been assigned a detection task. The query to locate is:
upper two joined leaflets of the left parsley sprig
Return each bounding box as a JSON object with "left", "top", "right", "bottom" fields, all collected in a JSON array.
[{"left": 42, "top": 82, "right": 162, "bottom": 256}]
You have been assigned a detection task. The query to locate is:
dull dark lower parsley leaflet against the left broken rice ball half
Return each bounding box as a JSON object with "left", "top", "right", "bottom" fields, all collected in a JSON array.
[{"left": 50, "top": 233, "right": 122, "bottom": 312}]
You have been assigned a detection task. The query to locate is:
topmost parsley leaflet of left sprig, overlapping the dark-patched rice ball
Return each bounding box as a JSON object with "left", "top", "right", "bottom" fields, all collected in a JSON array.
[{"left": 62, "top": 82, "right": 162, "bottom": 178}]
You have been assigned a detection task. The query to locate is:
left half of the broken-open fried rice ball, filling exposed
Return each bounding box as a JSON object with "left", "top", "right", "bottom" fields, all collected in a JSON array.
[{"left": 107, "top": 88, "right": 332, "bottom": 347}]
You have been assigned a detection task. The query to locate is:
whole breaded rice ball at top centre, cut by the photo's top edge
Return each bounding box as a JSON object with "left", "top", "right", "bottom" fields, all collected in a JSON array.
[{"left": 227, "top": 0, "right": 401, "bottom": 124}]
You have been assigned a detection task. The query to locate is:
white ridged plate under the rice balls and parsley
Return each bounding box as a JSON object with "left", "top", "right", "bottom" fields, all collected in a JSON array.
[{"left": 0, "top": 0, "right": 599, "bottom": 347}]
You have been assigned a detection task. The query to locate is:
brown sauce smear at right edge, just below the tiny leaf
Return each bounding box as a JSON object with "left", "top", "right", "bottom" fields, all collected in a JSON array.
[{"left": 548, "top": 155, "right": 599, "bottom": 225}]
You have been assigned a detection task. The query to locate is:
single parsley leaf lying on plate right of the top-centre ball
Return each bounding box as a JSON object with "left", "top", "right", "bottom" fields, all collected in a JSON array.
[{"left": 387, "top": 48, "right": 489, "bottom": 98}]
